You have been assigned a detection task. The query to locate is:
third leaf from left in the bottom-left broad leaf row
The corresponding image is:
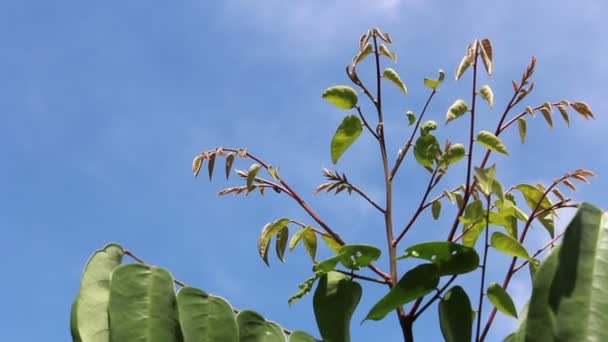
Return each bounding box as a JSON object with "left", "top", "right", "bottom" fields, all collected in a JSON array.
[{"left": 177, "top": 287, "right": 239, "bottom": 342}]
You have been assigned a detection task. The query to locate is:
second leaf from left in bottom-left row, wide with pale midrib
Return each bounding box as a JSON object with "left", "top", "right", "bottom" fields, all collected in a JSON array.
[{"left": 109, "top": 264, "right": 181, "bottom": 342}]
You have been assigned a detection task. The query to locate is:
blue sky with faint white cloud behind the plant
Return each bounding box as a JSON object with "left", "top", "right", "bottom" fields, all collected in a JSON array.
[{"left": 0, "top": 0, "right": 608, "bottom": 341}]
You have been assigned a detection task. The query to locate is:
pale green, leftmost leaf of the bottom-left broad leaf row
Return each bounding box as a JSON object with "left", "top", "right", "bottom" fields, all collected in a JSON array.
[{"left": 71, "top": 243, "right": 124, "bottom": 342}]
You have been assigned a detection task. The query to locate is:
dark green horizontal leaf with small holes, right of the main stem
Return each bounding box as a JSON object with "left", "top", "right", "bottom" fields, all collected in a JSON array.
[{"left": 397, "top": 241, "right": 479, "bottom": 276}]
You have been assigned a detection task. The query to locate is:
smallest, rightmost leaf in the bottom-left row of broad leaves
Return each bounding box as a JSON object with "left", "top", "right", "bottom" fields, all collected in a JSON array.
[{"left": 236, "top": 310, "right": 286, "bottom": 342}]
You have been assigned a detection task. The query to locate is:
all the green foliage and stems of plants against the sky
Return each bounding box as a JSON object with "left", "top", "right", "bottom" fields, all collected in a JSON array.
[{"left": 72, "top": 28, "right": 608, "bottom": 342}]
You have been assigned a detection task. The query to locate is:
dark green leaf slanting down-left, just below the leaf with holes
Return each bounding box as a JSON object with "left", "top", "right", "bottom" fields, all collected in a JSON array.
[{"left": 364, "top": 264, "right": 439, "bottom": 321}]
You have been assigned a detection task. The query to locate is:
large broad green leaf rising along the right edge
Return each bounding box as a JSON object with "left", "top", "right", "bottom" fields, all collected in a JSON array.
[{"left": 511, "top": 203, "right": 608, "bottom": 341}]
